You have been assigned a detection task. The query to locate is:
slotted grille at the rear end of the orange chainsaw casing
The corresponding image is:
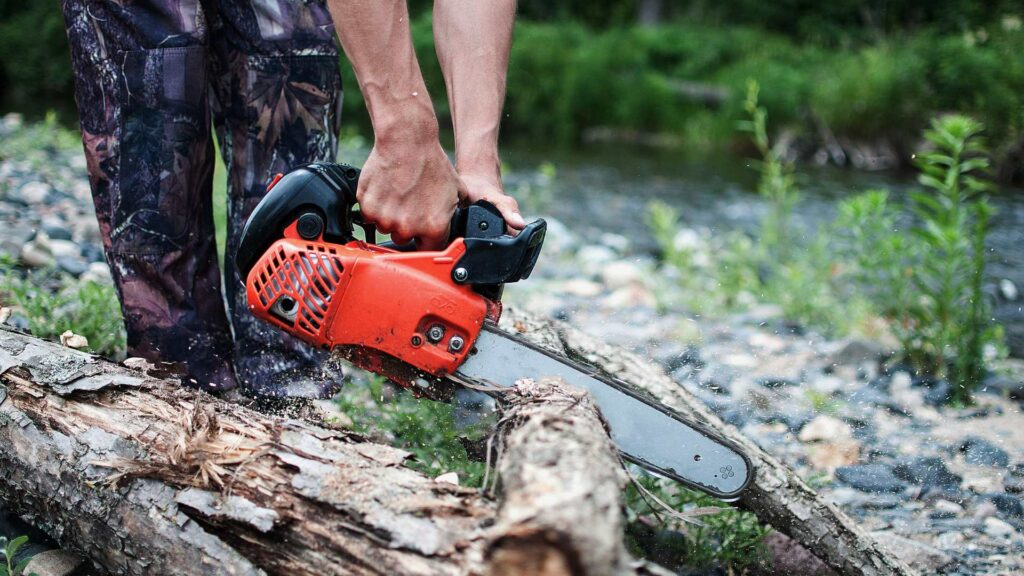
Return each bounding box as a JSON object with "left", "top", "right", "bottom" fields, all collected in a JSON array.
[{"left": 253, "top": 244, "right": 344, "bottom": 337}]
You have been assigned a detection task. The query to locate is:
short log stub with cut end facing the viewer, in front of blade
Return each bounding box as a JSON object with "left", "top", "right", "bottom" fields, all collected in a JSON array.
[{"left": 485, "top": 378, "right": 628, "bottom": 576}]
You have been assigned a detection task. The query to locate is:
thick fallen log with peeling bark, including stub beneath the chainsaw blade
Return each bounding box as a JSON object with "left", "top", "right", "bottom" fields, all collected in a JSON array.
[{"left": 0, "top": 329, "right": 659, "bottom": 575}]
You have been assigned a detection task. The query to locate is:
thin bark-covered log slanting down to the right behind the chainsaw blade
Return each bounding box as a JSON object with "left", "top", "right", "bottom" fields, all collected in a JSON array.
[{"left": 502, "top": 308, "right": 913, "bottom": 576}]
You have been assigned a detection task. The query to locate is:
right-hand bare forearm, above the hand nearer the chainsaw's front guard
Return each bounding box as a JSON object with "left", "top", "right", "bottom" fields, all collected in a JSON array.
[{"left": 434, "top": 0, "right": 516, "bottom": 178}]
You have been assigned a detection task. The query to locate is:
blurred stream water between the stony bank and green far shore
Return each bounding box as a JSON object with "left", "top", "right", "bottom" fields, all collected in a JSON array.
[{"left": 504, "top": 140, "right": 1024, "bottom": 357}]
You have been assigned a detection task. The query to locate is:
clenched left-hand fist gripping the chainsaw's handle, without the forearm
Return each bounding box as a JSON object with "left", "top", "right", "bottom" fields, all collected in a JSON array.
[{"left": 355, "top": 137, "right": 459, "bottom": 250}]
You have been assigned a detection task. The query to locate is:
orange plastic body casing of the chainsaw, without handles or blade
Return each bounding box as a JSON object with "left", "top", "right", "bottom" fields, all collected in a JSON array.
[{"left": 246, "top": 222, "right": 501, "bottom": 386}]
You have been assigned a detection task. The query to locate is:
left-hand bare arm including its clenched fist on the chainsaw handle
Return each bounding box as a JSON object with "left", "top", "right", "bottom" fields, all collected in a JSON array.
[{"left": 328, "top": 0, "right": 459, "bottom": 249}]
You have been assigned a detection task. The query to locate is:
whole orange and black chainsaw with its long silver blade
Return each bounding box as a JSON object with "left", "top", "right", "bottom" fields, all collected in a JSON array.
[{"left": 236, "top": 163, "right": 752, "bottom": 499}]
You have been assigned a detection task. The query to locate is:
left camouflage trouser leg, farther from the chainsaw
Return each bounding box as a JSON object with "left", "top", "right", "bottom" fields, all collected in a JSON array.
[{"left": 63, "top": 0, "right": 236, "bottom": 389}]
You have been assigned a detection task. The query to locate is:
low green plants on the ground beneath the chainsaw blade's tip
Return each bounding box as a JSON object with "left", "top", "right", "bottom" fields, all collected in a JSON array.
[{"left": 626, "top": 476, "right": 771, "bottom": 574}]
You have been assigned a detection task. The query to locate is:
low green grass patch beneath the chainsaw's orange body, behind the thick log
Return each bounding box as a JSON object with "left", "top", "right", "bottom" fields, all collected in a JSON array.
[{"left": 337, "top": 374, "right": 485, "bottom": 487}]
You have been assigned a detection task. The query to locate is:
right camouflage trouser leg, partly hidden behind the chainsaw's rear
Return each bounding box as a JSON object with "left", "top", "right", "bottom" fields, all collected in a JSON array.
[{"left": 210, "top": 0, "right": 341, "bottom": 397}]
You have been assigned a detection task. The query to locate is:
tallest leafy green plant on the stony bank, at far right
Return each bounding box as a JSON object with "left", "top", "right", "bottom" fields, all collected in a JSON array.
[{"left": 902, "top": 116, "right": 994, "bottom": 402}]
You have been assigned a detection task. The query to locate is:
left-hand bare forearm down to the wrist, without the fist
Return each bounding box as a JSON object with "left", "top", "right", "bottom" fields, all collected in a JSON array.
[{"left": 328, "top": 0, "right": 437, "bottom": 147}]
